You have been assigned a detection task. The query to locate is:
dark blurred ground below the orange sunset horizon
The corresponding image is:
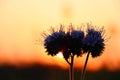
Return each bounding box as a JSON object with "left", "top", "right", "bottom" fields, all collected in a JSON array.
[{"left": 0, "top": 65, "right": 120, "bottom": 80}]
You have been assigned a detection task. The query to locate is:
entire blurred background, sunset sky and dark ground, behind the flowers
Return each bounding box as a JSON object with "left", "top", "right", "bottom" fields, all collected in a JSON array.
[{"left": 0, "top": 0, "right": 120, "bottom": 80}]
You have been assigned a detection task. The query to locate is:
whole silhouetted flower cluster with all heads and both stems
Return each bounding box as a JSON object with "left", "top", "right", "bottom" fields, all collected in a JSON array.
[{"left": 44, "top": 23, "right": 105, "bottom": 80}]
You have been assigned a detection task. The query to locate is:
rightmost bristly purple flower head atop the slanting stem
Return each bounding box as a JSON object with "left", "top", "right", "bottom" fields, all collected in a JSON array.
[{"left": 83, "top": 25, "right": 105, "bottom": 57}]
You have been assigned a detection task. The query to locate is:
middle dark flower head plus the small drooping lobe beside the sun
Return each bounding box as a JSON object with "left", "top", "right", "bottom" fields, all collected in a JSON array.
[{"left": 63, "top": 30, "right": 84, "bottom": 59}]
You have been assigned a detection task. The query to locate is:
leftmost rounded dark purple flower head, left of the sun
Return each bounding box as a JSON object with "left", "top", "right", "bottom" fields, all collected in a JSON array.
[{"left": 44, "top": 32, "right": 66, "bottom": 56}]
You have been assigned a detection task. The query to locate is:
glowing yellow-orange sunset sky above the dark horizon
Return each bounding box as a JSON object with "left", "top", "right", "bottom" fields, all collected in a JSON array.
[{"left": 0, "top": 0, "right": 120, "bottom": 70}]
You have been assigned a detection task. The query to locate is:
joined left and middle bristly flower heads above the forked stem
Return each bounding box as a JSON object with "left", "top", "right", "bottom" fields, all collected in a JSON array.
[{"left": 44, "top": 26, "right": 84, "bottom": 59}]
